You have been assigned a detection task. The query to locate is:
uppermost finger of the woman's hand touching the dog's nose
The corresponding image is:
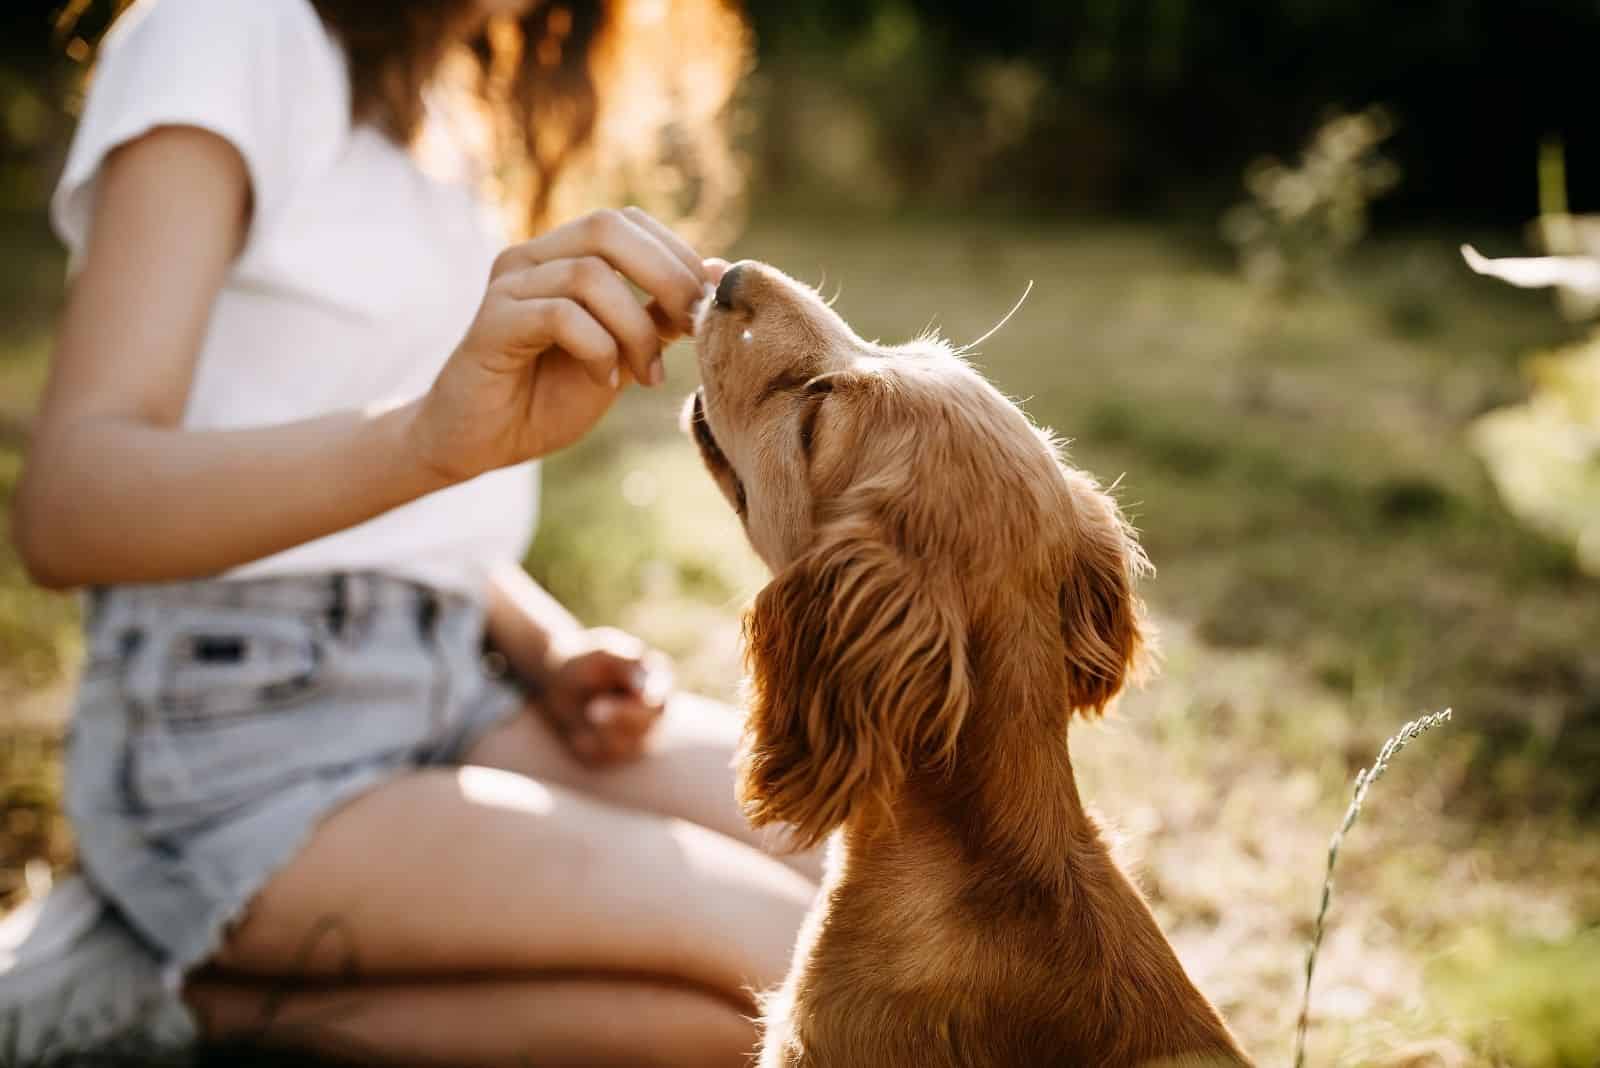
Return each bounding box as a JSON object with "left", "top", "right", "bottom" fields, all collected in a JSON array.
[{"left": 494, "top": 211, "right": 702, "bottom": 325}]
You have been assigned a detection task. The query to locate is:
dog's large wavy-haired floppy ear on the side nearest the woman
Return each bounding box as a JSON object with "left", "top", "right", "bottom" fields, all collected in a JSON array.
[{"left": 739, "top": 536, "right": 970, "bottom": 847}]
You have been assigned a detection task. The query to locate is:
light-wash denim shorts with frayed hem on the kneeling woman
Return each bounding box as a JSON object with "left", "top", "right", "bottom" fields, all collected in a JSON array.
[{"left": 67, "top": 572, "right": 523, "bottom": 988}]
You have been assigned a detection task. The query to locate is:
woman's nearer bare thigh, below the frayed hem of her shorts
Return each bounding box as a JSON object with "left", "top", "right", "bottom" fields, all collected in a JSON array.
[{"left": 216, "top": 766, "right": 814, "bottom": 1006}]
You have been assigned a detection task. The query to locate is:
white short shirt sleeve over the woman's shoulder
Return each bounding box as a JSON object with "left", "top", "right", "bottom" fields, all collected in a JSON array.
[{"left": 51, "top": 0, "right": 349, "bottom": 265}]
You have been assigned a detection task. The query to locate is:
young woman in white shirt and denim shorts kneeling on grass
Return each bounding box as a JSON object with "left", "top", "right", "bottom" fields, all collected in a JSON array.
[{"left": 0, "top": 0, "right": 816, "bottom": 1065}]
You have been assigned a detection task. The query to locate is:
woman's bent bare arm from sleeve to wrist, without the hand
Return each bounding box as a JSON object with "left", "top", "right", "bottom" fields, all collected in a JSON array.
[{"left": 14, "top": 126, "right": 443, "bottom": 587}]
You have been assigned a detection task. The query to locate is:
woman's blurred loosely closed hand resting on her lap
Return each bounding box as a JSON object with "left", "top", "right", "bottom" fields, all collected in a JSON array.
[{"left": 530, "top": 627, "right": 672, "bottom": 766}]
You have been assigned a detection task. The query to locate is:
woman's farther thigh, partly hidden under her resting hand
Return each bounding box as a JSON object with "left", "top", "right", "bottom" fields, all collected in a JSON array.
[{"left": 466, "top": 694, "right": 822, "bottom": 879}]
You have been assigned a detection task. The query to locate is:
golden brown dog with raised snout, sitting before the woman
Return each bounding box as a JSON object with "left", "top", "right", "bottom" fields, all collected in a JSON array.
[{"left": 686, "top": 264, "right": 1246, "bottom": 1068}]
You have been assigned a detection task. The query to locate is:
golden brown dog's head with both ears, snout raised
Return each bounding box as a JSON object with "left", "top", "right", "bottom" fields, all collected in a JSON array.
[{"left": 685, "top": 261, "right": 1146, "bottom": 844}]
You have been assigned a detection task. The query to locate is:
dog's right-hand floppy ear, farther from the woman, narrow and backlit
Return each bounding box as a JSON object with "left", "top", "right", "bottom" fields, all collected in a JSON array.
[{"left": 1058, "top": 468, "right": 1150, "bottom": 715}]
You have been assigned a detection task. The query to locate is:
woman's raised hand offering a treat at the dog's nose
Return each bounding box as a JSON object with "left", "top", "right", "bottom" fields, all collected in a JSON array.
[{"left": 411, "top": 208, "right": 707, "bottom": 481}]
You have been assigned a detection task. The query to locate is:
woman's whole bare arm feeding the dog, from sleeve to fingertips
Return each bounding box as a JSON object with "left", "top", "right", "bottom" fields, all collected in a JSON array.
[{"left": 14, "top": 126, "right": 704, "bottom": 588}]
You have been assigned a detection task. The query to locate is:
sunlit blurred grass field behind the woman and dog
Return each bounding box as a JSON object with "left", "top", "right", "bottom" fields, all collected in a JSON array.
[{"left": 0, "top": 206, "right": 1600, "bottom": 1068}]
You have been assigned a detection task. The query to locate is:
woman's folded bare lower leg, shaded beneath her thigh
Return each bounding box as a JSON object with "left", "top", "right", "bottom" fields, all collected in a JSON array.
[{"left": 189, "top": 975, "right": 757, "bottom": 1068}]
